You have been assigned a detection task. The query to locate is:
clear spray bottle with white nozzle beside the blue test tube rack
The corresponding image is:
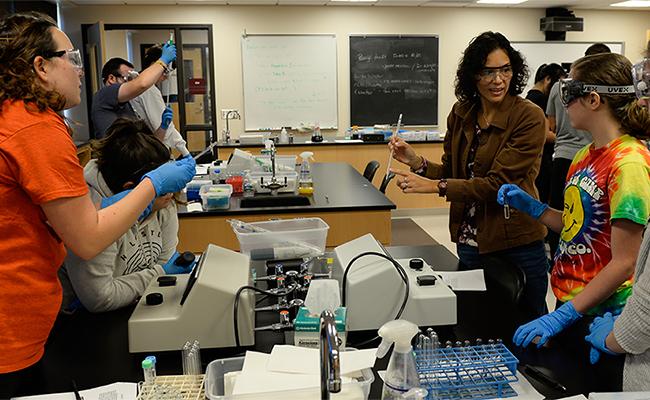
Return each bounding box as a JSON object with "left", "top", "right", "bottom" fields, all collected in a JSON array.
[{"left": 377, "top": 319, "right": 420, "bottom": 400}]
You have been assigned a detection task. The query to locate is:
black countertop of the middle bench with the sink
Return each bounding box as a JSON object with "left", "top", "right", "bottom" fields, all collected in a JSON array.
[{"left": 178, "top": 163, "right": 396, "bottom": 218}]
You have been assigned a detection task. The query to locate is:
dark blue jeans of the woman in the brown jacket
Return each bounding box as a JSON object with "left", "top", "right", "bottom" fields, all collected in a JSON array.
[{"left": 456, "top": 240, "right": 549, "bottom": 318}]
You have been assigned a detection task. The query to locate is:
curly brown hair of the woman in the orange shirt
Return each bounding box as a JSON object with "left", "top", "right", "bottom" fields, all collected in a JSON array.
[{"left": 0, "top": 12, "right": 65, "bottom": 113}]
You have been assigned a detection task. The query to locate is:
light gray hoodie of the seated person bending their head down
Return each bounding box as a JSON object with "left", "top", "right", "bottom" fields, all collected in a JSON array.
[{"left": 59, "top": 160, "right": 178, "bottom": 312}]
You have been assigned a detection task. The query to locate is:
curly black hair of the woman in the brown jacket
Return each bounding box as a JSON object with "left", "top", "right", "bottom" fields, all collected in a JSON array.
[{"left": 454, "top": 31, "right": 528, "bottom": 102}]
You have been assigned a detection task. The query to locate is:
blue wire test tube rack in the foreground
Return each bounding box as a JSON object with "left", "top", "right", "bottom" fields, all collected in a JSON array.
[{"left": 414, "top": 343, "right": 519, "bottom": 400}]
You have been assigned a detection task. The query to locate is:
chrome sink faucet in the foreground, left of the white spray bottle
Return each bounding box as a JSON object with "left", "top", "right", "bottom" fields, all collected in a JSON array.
[{"left": 319, "top": 310, "right": 341, "bottom": 400}]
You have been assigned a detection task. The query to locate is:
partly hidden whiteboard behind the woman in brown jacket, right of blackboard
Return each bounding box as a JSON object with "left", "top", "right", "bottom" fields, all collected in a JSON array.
[{"left": 511, "top": 42, "right": 625, "bottom": 96}]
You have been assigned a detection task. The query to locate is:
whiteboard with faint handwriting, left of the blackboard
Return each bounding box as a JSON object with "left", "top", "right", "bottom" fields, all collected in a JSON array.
[{"left": 242, "top": 35, "right": 338, "bottom": 131}]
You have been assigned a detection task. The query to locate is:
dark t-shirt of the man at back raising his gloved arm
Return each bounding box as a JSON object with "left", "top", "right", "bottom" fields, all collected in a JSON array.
[{"left": 90, "top": 83, "right": 137, "bottom": 139}]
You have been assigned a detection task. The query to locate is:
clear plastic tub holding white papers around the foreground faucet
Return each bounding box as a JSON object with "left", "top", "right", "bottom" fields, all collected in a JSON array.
[{"left": 205, "top": 357, "right": 375, "bottom": 400}]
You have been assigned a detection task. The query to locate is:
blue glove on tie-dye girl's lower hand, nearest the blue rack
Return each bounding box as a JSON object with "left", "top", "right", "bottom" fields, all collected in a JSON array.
[{"left": 512, "top": 301, "right": 582, "bottom": 348}]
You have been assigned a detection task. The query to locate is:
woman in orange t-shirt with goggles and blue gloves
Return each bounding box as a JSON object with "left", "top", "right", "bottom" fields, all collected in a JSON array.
[{"left": 0, "top": 13, "right": 195, "bottom": 398}]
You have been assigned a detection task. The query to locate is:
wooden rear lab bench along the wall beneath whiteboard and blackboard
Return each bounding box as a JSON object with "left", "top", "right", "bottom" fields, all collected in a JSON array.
[{"left": 217, "top": 138, "right": 449, "bottom": 210}]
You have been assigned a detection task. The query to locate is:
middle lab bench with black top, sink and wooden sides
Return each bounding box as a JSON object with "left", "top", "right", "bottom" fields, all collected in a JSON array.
[{"left": 178, "top": 163, "right": 395, "bottom": 252}]
